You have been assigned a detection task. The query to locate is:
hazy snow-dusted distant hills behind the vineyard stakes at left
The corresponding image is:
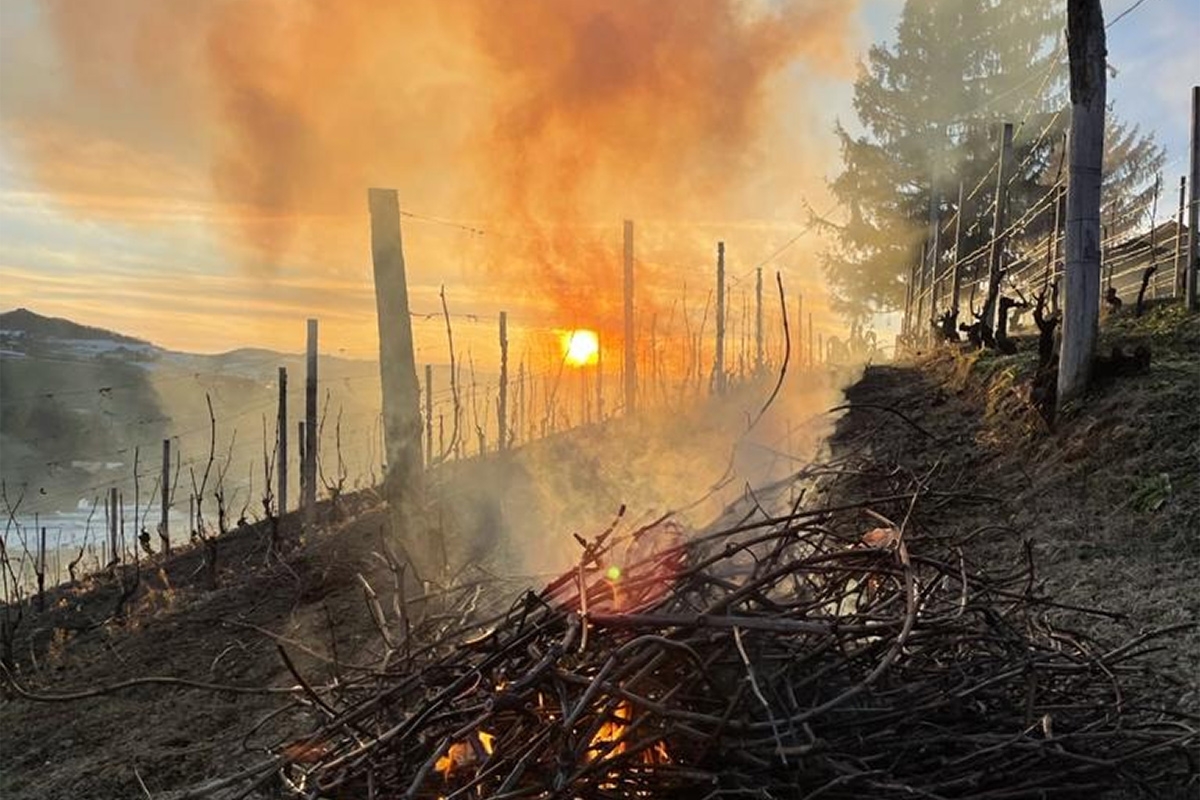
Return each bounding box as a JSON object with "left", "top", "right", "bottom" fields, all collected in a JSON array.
[{"left": 0, "top": 308, "right": 381, "bottom": 515}]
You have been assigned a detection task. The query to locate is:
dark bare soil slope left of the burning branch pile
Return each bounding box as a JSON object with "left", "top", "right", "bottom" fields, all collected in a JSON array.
[{"left": 0, "top": 498, "right": 393, "bottom": 800}]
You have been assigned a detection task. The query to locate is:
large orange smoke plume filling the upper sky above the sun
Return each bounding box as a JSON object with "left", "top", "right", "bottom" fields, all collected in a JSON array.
[{"left": 7, "top": 0, "right": 856, "bottom": 321}]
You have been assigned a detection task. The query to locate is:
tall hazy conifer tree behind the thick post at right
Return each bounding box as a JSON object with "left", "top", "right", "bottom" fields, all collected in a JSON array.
[{"left": 823, "top": 0, "right": 1163, "bottom": 317}]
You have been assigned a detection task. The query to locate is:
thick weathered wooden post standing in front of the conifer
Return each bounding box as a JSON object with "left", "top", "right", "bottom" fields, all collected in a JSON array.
[{"left": 1057, "top": 0, "right": 1106, "bottom": 408}]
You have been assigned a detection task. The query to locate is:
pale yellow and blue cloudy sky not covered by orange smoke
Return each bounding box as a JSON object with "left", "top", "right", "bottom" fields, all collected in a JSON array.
[{"left": 0, "top": 0, "right": 1200, "bottom": 360}]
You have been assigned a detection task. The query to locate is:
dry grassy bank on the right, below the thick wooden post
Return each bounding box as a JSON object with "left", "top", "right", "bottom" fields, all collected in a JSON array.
[{"left": 841, "top": 305, "right": 1200, "bottom": 712}]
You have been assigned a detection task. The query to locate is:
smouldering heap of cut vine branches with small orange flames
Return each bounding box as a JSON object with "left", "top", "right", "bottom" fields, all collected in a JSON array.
[{"left": 271, "top": 474, "right": 1200, "bottom": 800}]
